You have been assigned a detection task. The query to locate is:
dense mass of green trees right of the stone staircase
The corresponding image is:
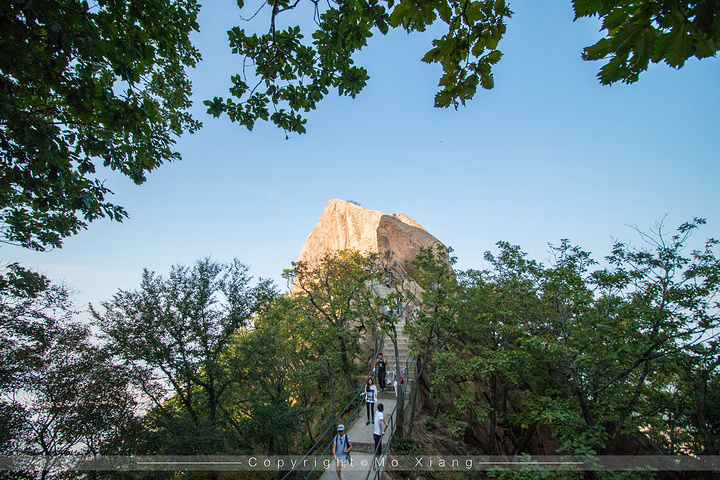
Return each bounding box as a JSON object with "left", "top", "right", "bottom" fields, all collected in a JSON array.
[{"left": 418, "top": 219, "right": 720, "bottom": 464}]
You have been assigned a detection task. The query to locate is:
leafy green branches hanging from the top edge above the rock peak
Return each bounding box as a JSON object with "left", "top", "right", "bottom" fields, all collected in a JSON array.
[{"left": 205, "top": 0, "right": 512, "bottom": 133}]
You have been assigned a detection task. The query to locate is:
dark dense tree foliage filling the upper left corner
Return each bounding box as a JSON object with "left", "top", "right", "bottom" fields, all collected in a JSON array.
[{"left": 0, "top": 0, "right": 200, "bottom": 250}]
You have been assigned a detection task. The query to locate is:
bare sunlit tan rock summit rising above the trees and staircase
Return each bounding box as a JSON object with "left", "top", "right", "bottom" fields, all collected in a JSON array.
[{"left": 298, "top": 199, "right": 441, "bottom": 278}]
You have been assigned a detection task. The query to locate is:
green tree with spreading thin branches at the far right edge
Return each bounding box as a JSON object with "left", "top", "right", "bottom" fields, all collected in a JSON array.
[{"left": 589, "top": 218, "right": 720, "bottom": 453}]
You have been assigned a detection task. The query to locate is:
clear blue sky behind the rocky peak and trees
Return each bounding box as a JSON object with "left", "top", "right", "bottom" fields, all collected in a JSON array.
[{"left": 7, "top": 0, "right": 720, "bottom": 314}]
